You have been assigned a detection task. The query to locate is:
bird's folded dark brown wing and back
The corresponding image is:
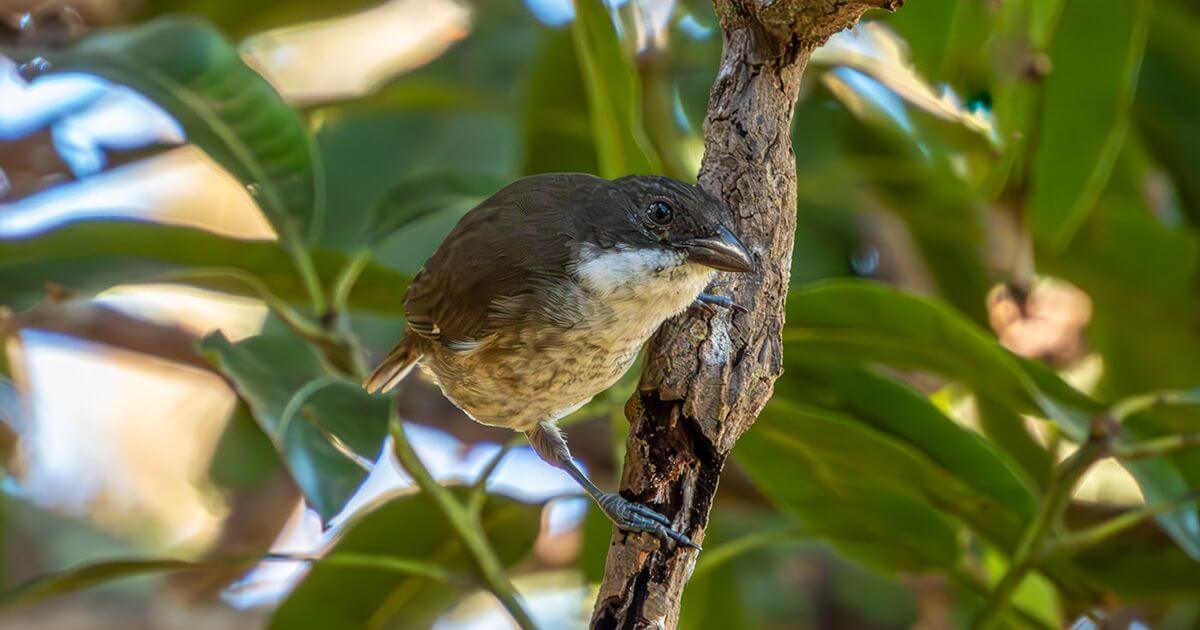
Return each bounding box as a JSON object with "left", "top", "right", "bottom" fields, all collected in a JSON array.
[{"left": 404, "top": 174, "right": 605, "bottom": 349}]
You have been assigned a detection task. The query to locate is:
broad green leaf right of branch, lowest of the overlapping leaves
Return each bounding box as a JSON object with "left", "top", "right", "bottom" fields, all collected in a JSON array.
[{"left": 736, "top": 397, "right": 1096, "bottom": 609}]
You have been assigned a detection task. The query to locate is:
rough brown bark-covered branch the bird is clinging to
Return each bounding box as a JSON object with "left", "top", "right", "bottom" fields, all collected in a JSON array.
[{"left": 592, "top": 0, "right": 902, "bottom": 628}]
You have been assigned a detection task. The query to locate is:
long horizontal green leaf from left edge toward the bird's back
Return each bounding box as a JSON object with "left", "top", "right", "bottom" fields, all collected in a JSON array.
[{"left": 0, "top": 221, "right": 408, "bottom": 314}]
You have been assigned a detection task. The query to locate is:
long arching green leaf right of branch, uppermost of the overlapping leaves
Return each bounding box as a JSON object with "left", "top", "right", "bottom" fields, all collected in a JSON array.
[{"left": 784, "top": 281, "right": 1200, "bottom": 557}]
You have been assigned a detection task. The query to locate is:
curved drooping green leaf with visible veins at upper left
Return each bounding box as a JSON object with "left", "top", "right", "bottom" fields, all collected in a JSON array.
[{"left": 20, "top": 17, "right": 322, "bottom": 244}]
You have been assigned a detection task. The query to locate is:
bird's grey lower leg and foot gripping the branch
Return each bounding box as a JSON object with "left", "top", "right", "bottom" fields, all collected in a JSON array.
[{"left": 526, "top": 422, "right": 700, "bottom": 550}]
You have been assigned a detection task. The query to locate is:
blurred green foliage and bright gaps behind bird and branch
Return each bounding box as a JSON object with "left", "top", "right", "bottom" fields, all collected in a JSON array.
[{"left": 0, "top": 0, "right": 1200, "bottom": 628}]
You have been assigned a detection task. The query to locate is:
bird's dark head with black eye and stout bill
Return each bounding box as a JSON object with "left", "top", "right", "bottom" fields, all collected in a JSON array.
[{"left": 613, "top": 175, "right": 754, "bottom": 274}]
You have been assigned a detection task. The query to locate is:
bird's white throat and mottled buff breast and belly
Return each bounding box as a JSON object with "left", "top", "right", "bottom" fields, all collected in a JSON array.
[{"left": 412, "top": 246, "right": 713, "bottom": 430}]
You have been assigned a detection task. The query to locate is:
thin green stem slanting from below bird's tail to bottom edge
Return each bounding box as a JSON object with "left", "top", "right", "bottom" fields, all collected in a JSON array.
[{"left": 388, "top": 408, "right": 536, "bottom": 629}]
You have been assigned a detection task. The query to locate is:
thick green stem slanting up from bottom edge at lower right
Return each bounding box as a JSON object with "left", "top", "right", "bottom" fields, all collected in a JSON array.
[{"left": 971, "top": 418, "right": 1109, "bottom": 630}]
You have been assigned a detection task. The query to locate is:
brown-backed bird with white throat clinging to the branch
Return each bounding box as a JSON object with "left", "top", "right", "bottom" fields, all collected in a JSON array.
[{"left": 364, "top": 173, "right": 755, "bottom": 548}]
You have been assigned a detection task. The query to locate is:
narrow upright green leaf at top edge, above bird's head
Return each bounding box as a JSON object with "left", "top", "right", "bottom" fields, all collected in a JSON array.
[{"left": 571, "top": 0, "right": 661, "bottom": 178}]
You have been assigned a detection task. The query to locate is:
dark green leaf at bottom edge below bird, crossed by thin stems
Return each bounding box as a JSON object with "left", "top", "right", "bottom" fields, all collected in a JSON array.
[{"left": 271, "top": 493, "right": 541, "bottom": 629}]
